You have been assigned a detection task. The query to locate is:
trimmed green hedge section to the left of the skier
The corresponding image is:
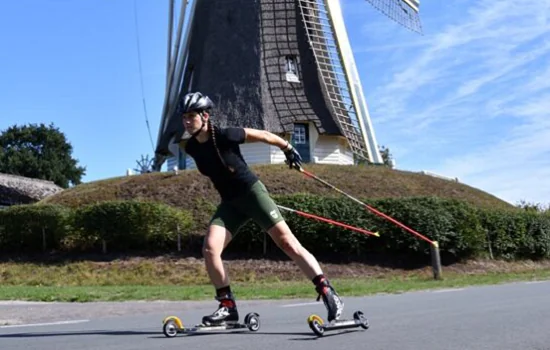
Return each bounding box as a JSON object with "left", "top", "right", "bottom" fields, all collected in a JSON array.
[{"left": 0, "top": 201, "right": 193, "bottom": 253}]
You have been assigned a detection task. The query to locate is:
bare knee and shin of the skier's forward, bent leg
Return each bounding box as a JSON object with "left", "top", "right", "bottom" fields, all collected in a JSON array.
[{"left": 202, "top": 225, "right": 232, "bottom": 289}]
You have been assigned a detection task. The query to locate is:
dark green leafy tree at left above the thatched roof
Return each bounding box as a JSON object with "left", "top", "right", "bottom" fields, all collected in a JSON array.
[{"left": 0, "top": 123, "right": 86, "bottom": 188}]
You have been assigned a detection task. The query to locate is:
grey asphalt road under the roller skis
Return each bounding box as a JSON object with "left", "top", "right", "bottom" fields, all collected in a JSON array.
[{"left": 0, "top": 281, "right": 550, "bottom": 350}]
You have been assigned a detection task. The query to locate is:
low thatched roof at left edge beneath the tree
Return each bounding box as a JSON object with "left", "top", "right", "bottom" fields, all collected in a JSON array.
[{"left": 0, "top": 173, "right": 63, "bottom": 205}]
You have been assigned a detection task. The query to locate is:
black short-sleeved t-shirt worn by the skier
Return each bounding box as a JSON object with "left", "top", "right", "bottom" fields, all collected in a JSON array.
[{"left": 185, "top": 127, "right": 258, "bottom": 200}]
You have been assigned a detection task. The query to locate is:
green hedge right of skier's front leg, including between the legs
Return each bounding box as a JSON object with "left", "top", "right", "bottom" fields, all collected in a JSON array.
[{"left": 228, "top": 194, "right": 550, "bottom": 261}]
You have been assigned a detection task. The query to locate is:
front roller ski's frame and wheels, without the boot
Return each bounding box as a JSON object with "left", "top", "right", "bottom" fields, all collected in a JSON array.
[{"left": 162, "top": 312, "right": 260, "bottom": 338}]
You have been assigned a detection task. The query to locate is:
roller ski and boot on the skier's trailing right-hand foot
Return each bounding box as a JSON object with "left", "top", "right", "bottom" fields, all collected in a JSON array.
[{"left": 307, "top": 280, "right": 369, "bottom": 336}]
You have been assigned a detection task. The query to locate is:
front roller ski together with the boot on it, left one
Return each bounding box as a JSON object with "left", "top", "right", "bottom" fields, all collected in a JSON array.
[{"left": 162, "top": 296, "right": 260, "bottom": 338}]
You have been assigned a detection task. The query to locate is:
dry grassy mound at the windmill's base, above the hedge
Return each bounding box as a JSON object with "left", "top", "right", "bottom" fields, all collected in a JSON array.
[{"left": 40, "top": 164, "right": 514, "bottom": 235}]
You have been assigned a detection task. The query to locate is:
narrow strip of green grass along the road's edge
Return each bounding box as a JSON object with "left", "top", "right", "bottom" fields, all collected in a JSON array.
[{"left": 0, "top": 270, "right": 550, "bottom": 302}]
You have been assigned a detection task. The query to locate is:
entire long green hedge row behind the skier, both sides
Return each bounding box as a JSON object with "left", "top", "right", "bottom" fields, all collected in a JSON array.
[{"left": 0, "top": 195, "right": 550, "bottom": 260}]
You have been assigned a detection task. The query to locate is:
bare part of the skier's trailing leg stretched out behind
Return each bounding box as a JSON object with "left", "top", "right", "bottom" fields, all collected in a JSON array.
[{"left": 267, "top": 221, "right": 322, "bottom": 279}]
